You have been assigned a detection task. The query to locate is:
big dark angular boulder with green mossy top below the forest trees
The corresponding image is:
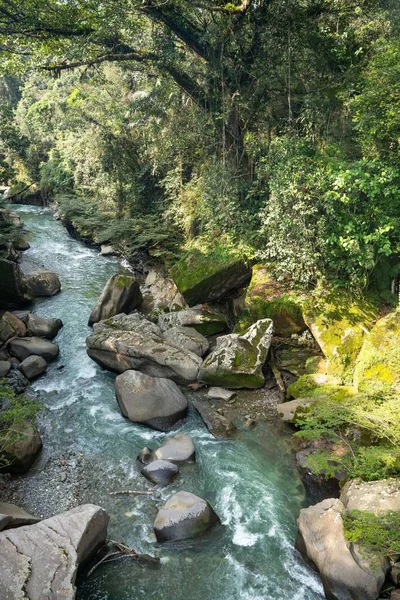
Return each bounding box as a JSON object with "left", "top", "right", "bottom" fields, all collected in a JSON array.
[{"left": 170, "top": 239, "right": 251, "bottom": 306}]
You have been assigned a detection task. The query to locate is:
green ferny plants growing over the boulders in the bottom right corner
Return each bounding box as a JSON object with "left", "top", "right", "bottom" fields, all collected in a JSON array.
[{"left": 344, "top": 510, "right": 400, "bottom": 562}]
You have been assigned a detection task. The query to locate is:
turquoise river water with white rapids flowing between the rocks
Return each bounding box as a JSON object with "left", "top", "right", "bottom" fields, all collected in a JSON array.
[{"left": 13, "top": 206, "right": 323, "bottom": 600}]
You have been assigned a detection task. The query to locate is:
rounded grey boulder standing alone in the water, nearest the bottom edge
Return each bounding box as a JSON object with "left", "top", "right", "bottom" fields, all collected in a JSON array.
[{"left": 154, "top": 492, "right": 220, "bottom": 542}]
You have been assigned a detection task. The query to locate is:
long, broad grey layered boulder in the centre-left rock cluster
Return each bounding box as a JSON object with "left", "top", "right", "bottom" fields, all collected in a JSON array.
[{"left": 86, "top": 314, "right": 202, "bottom": 383}]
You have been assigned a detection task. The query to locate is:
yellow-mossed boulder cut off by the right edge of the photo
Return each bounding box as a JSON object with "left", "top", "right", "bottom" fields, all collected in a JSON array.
[{"left": 354, "top": 310, "right": 400, "bottom": 395}]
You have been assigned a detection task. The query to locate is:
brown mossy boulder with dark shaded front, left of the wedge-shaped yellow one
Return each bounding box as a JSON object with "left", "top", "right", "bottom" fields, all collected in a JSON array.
[{"left": 243, "top": 265, "right": 307, "bottom": 337}]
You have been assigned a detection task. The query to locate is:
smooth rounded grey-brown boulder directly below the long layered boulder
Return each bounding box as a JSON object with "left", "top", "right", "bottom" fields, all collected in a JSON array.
[{"left": 115, "top": 371, "right": 187, "bottom": 431}]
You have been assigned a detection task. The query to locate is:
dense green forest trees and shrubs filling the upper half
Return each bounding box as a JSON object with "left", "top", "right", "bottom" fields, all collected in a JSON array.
[{"left": 0, "top": 0, "right": 400, "bottom": 289}]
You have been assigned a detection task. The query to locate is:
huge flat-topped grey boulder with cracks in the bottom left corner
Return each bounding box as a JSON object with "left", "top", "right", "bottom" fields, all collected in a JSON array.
[{"left": 0, "top": 504, "right": 108, "bottom": 600}]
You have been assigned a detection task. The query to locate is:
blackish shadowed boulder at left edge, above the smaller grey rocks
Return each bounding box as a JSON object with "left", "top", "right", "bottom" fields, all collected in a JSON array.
[{"left": 0, "top": 258, "right": 33, "bottom": 308}]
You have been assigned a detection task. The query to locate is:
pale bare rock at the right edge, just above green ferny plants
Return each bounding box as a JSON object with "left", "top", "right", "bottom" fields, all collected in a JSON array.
[{"left": 340, "top": 477, "right": 400, "bottom": 515}]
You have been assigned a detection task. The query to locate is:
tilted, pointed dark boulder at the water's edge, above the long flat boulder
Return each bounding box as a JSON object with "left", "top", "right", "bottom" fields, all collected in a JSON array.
[{"left": 89, "top": 273, "right": 142, "bottom": 325}]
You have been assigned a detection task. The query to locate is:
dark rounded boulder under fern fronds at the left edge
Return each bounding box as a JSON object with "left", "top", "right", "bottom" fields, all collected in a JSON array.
[{"left": 0, "top": 421, "right": 42, "bottom": 474}]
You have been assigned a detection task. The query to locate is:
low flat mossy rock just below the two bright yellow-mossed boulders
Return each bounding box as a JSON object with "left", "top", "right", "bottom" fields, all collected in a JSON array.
[{"left": 287, "top": 374, "right": 357, "bottom": 402}]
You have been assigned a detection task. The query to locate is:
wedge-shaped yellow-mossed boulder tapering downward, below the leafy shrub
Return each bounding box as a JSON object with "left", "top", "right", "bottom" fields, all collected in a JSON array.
[{"left": 303, "top": 296, "right": 378, "bottom": 382}]
